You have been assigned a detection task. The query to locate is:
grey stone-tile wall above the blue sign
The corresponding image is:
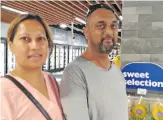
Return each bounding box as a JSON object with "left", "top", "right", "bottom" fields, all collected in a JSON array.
[{"left": 121, "top": 1, "right": 163, "bottom": 94}]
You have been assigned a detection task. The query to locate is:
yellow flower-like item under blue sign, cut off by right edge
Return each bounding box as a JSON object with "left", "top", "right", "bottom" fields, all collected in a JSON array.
[{"left": 152, "top": 103, "right": 163, "bottom": 120}]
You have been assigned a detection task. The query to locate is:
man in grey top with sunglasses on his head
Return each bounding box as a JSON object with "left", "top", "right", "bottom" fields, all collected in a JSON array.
[{"left": 60, "top": 4, "right": 128, "bottom": 120}]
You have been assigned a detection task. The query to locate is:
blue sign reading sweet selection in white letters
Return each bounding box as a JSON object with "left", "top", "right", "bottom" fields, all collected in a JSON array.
[{"left": 122, "top": 62, "right": 163, "bottom": 91}]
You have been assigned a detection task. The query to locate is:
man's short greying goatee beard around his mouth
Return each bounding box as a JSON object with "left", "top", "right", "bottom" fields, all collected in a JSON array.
[{"left": 99, "top": 38, "right": 116, "bottom": 54}]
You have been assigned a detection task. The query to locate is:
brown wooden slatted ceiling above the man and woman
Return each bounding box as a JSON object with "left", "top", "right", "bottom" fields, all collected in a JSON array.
[{"left": 1, "top": 0, "right": 122, "bottom": 25}]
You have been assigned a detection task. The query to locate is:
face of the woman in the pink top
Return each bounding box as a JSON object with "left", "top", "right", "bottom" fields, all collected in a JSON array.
[{"left": 9, "top": 20, "right": 48, "bottom": 69}]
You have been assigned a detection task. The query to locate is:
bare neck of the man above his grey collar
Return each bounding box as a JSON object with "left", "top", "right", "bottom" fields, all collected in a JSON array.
[{"left": 82, "top": 49, "right": 110, "bottom": 69}]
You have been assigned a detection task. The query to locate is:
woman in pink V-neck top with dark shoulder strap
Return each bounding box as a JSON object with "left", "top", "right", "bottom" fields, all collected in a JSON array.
[{"left": 0, "top": 14, "right": 62, "bottom": 120}]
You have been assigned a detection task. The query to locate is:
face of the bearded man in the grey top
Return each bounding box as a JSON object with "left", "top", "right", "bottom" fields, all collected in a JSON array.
[{"left": 84, "top": 8, "right": 118, "bottom": 54}]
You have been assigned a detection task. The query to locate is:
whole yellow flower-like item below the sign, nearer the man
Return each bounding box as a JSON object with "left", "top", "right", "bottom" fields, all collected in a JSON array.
[{"left": 132, "top": 102, "right": 147, "bottom": 119}]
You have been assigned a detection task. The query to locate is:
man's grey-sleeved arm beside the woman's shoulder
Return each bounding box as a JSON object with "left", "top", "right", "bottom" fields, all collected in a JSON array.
[{"left": 60, "top": 65, "right": 90, "bottom": 120}]
